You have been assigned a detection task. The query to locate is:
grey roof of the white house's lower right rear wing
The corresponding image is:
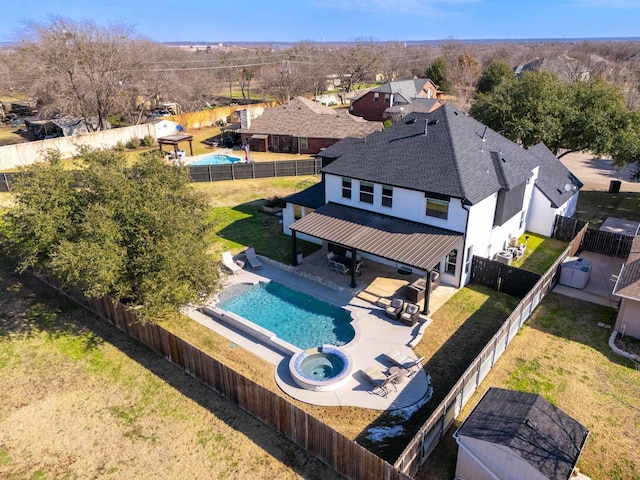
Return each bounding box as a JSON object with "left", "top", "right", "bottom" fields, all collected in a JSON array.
[{"left": 528, "top": 143, "right": 582, "bottom": 208}]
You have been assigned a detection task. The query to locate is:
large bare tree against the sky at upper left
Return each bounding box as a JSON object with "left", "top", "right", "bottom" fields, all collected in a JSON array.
[{"left": 18, "top": 17, "right": 148, "bottom": 130}]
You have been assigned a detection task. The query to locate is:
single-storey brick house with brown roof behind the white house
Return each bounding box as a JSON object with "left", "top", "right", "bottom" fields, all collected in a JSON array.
[{"left": 238, "top": 97, "right": 382, "bottom": 154}]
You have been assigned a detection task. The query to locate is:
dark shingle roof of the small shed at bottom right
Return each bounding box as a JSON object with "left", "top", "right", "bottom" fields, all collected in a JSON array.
[{"left": 455, "top": 388, "right": 589, "bottom": 479}]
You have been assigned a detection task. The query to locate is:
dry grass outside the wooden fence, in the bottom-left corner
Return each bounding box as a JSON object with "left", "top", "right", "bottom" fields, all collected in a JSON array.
[{"left": 0, "top": 260, "right": 344, "bottom": 479}]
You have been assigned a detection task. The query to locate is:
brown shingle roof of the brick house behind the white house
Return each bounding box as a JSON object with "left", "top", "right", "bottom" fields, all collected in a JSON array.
[{"left": 238, "top": 97, "right": 382, "bottom": 138}]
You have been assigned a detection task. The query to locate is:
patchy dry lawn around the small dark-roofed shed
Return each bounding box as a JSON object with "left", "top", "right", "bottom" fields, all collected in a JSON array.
[{"left": 418, "top": 294, "right": 640, "bottom": 480}]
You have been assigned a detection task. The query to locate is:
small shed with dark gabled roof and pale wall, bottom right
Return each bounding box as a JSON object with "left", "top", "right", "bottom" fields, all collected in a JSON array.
[{"left": 453, "top": 388, "right": 589, "bottom": 480}]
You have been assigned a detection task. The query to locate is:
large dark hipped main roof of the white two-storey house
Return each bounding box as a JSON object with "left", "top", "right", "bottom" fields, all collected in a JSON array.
[{"left": 320, "top": 104, "right": 537, "bottom": 204}]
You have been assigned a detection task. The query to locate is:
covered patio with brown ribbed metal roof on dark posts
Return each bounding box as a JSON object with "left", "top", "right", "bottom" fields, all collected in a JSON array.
[{"left": 290, "top": 203, "right": 463, "bottom": 314}]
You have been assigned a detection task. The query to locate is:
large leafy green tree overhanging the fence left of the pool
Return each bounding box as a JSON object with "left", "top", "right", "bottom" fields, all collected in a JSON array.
[{"left": 2, "top": 149, "right": 219, "bottom": 321}]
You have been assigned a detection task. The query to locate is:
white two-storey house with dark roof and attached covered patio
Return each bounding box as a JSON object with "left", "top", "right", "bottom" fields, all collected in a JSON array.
[{"left": 283, "top": 104, "right": 582, "bottom": 300}]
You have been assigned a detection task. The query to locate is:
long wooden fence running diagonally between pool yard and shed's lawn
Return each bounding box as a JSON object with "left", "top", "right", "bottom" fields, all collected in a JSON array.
[{"left": 395, "top": 226, "right": 586, "bottom": 475}]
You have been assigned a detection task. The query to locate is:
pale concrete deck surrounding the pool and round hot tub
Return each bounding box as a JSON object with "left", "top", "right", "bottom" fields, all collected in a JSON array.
[{"left": 188, "top": 257, "right": 446, "bottom": 410}]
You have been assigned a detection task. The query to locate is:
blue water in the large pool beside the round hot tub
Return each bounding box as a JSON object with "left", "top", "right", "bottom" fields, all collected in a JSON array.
[{"left": 217, "top": 281, "right": 355, "bottom": 350}]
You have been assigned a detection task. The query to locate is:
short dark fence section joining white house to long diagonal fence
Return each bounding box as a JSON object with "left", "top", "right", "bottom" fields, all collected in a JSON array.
[{"left": 471, "top": 255, "right": 540, "bottom": 298}]
